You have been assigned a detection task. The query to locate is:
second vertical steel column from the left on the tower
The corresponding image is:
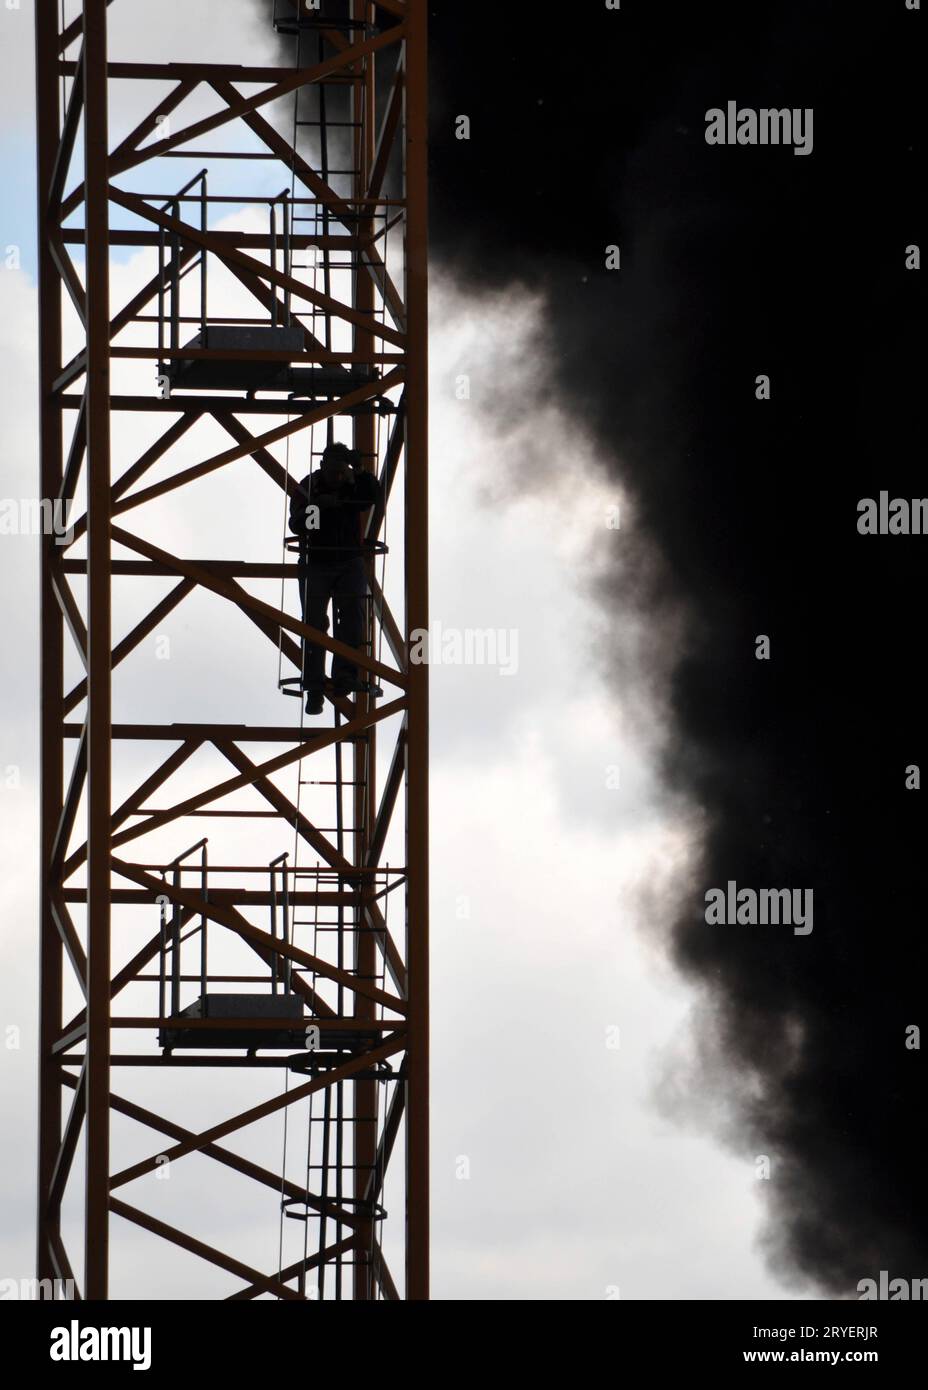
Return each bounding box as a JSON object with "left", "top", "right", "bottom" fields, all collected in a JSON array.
[{"left": 83, "top": 0, "right": 111, "bottom": 1298}]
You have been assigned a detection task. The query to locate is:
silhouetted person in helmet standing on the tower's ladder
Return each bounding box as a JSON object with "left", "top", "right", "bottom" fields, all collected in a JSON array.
[{"left": 290, "top": 443, "right": 381, "bottom": 714}]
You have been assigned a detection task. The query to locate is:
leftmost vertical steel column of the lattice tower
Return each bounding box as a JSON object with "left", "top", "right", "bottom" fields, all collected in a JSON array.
[{"left": 36, "top": 6, "right": 64, "bottom": 1279}]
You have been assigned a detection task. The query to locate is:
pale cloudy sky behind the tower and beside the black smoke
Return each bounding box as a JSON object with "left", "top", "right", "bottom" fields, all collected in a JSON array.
[{"left": 0, "top": 0, "right": 809, "bottom": 1300}]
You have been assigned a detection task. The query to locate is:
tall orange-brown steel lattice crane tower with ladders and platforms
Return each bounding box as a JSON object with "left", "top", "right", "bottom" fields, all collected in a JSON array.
[{"left": 36, "top": 0, "right": 428, "bottom": 1300}]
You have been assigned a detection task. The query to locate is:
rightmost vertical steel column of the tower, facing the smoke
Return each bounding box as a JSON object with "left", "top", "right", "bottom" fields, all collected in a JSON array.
[{"left": 404, "top": 0, "right": 429, "bottom": 1300}]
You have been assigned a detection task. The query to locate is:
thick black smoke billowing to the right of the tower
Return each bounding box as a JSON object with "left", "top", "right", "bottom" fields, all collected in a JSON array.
[{"left": 431, "top": 0, "right": 928, "bottom": 1297}]
